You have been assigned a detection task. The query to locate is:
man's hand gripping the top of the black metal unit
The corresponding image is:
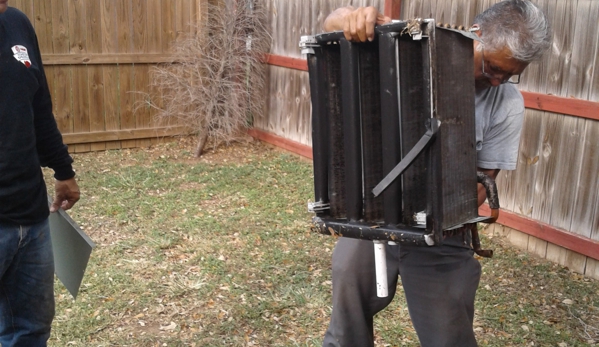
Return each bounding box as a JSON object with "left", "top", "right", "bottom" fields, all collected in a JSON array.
[{"left": 323, "top": 6, "right": 391, "bottom": 42}]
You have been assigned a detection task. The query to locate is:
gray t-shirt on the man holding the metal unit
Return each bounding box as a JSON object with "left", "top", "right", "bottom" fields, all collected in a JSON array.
[{"left": 475, "top": 83, "right": 524, "bottom": 170}]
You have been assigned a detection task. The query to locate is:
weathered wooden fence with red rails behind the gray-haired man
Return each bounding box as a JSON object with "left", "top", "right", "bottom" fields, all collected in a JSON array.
[{"left": 260, "top": 0, "right": 599, "bottom": 279}]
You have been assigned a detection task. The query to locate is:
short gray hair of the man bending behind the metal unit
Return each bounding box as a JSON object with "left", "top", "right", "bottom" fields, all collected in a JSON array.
[{"left": 474, "top": 0, "right": 552, "bottom": 62}]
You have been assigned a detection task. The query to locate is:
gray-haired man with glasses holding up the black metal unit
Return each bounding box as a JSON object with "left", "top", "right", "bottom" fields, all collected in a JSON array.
[{"left": 323, "top": 0, "right": 551, "bottom": 347}]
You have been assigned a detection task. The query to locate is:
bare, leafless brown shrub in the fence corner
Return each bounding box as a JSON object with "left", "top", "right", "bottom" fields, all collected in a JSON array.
[{"left": 151, "top": 0, "right": 271, "bottom": 157}]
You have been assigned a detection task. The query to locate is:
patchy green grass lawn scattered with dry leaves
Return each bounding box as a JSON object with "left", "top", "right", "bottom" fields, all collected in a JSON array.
[{"left": 46, "top": 139, "right": 599, "bottom": 347}]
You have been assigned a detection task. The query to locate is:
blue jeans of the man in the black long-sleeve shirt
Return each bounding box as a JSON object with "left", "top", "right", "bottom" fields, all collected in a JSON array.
[{"left": 0, "top": 219, "right": 54, "bottom": 347}]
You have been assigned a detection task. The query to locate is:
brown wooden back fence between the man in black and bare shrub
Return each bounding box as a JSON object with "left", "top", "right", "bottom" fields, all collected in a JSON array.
[{"left": 9, "top": 0, "right": 205, "bottom": 152}]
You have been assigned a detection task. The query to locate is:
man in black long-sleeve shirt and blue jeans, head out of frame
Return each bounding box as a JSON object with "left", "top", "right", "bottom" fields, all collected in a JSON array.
[{"left": 0, "top": 0, "right": 79, "bottom": 347}]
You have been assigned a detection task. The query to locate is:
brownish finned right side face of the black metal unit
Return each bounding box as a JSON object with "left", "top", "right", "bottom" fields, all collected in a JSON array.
[{"left": 427, "top": 23, "right": 478, "bottom": 242}]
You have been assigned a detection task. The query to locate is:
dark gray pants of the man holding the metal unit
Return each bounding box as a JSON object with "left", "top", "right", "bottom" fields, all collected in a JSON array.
[{"left": 323, "top": 236, "right": 481, "bottom": 347}]
